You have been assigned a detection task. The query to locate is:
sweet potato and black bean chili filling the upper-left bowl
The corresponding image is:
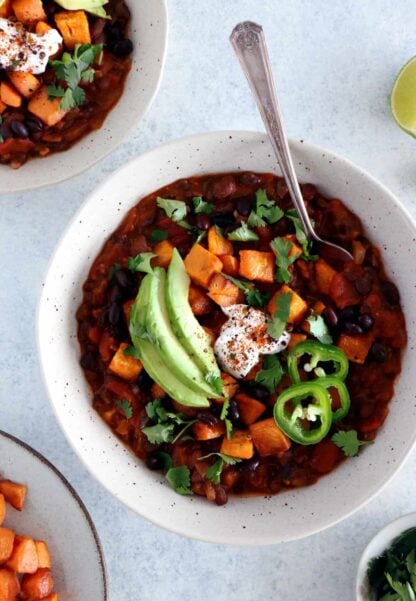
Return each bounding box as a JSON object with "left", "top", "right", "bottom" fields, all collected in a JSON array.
[{"left": 0, "top": 0, "right": 133, "bottom": 169}]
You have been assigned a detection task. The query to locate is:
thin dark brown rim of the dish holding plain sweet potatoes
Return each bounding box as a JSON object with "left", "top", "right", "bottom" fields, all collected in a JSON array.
[{"left": 0, "top": 430, "right": 109, "bottom": 601}]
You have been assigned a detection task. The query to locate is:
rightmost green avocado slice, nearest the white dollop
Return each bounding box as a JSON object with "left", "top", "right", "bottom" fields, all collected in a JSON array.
[{"left": 166, "top": 248, "right": 221, "bottom": 378}]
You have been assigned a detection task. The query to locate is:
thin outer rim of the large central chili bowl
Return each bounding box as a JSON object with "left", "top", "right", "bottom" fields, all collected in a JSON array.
[{"left": 36, "top": 130, "right": 416, "bottom": 546}]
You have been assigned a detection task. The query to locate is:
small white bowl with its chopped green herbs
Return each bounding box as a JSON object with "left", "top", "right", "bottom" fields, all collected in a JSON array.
[{"left": 356, "top": 513, "right": 416, "bottom": 601}]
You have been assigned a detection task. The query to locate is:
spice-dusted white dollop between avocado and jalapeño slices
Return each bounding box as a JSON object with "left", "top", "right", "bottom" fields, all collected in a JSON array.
[{"left": 214, "top": 305, "right": 290, "bottom": 378}]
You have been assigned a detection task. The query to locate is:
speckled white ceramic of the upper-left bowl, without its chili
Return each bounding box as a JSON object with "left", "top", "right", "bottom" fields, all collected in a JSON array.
[{"left": 0, "top": 0, "right": 168, "bottom": 193}]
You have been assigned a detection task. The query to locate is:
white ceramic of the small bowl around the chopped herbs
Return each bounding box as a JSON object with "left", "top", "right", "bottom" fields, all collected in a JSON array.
[{"left": 356, "top": 513, "right": 416, "bottom": 601}]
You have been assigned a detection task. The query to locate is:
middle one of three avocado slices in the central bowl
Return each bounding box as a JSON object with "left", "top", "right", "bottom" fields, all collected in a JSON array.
[{"left": 145, "top": 267, "right": 221, "bottom": 398}]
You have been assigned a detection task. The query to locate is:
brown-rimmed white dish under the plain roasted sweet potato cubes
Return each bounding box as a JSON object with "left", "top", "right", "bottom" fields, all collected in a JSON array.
[{"left": 0, "top": 431, "right": 108, "bottom": 601}]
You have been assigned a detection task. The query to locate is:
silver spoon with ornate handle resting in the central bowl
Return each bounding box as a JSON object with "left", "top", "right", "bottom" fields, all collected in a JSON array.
[{"left": 230, "top": 21, "right": 353, "bottom": 261}]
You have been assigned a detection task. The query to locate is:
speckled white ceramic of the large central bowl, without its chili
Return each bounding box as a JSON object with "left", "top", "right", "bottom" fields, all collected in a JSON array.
[{"left": 38, "top": 132, "right": 416, "bottom": 544}]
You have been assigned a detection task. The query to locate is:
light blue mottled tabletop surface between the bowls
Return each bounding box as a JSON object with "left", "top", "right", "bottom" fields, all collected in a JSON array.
[{"left": 0, "top": 0, "right": 416, "bottom": 601}]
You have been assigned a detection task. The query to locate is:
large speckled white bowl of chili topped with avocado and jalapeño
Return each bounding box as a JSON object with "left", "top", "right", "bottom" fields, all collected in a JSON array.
[{"left": 38, "top": 132, "right": 416, "bottom": 544}]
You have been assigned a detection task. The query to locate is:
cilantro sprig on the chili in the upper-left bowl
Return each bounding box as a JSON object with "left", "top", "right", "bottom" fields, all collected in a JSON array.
[{"left": 48, "top": 44, "right": 103, "bottom": 111}]
